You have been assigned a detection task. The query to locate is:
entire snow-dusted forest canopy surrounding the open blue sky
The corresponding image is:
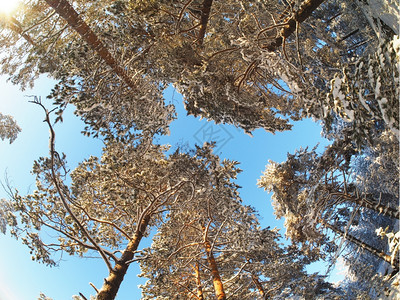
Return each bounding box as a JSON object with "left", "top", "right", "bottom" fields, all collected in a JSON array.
[{"left": 0, "top": 0, "right": 400, "bottom": 300}]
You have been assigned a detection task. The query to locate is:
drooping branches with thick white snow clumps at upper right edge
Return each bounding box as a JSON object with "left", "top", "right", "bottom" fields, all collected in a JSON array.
[{"left": 327, "top": 36, "right": 400, "bottom": 144}]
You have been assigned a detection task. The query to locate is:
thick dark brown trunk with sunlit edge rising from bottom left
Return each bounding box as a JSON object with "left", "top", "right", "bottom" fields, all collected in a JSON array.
[{"left": 97, "top": 214, "right": 150, "bottom": 300}]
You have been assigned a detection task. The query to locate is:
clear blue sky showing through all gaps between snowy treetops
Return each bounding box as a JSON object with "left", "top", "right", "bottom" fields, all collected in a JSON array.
[{"left": 0, "top": 77, "right": 334, "bottom": 300}]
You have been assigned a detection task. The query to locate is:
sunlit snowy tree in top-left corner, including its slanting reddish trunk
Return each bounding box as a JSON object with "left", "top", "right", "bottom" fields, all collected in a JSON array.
[{"left": 0, "top": 1, "right": 174, "bottom": 138}]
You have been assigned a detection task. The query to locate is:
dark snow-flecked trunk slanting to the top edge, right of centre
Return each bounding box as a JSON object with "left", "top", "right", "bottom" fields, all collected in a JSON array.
[{"left": 264, "top": 0, "right": 324, "bottom": 52}]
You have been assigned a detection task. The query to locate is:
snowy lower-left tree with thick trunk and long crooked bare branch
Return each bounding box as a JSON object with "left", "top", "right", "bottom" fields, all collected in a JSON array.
[{"left": 0, "top": 99, "right": 250, "bottom": 299}]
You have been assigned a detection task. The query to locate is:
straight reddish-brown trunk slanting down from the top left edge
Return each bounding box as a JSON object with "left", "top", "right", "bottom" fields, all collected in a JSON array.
[{"left": 46, "top": 0, "right": 136, "bottom": 90}]
